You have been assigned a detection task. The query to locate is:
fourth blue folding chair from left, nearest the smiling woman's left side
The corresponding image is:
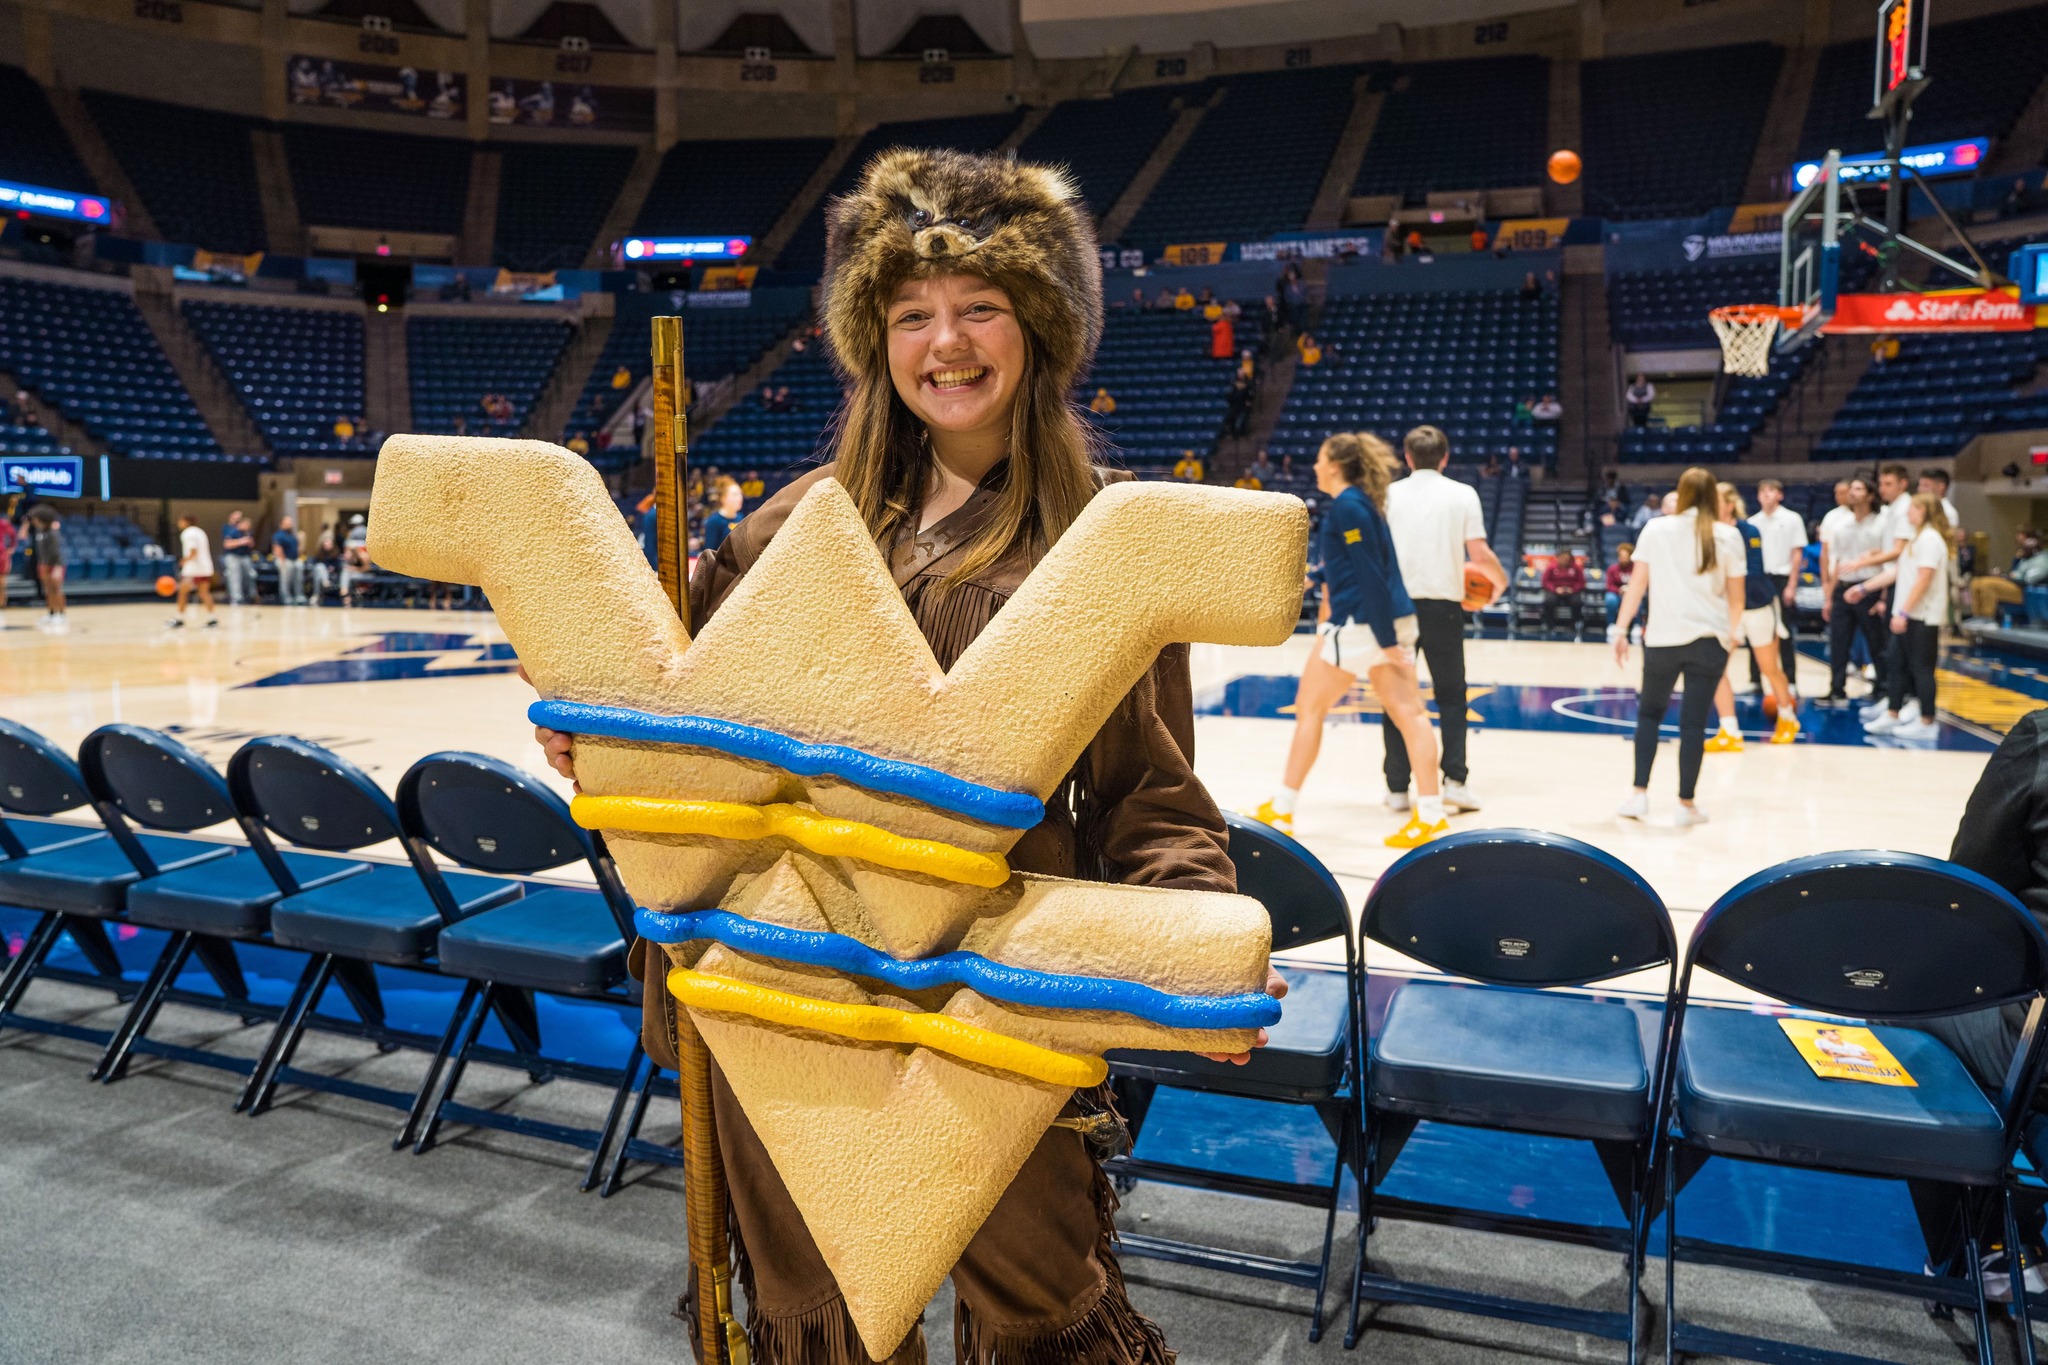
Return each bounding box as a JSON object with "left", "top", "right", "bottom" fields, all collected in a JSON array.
[{"left": 395, "top": 753, "right": 643, "bottom": 1189}]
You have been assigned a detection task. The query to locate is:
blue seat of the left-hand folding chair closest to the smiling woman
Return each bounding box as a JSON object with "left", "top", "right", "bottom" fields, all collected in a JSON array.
[{"left": 440, "top": 886, "right": 627, "bottom": 995}]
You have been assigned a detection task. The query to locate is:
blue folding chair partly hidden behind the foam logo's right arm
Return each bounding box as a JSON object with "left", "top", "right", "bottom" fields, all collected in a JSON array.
[{"left": 1106, "top": 814, "right": 1364, "bottom": 1340}]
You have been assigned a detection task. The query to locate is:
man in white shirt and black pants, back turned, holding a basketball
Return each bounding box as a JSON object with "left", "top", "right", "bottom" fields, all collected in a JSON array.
[{"left": 1380, "top": 426, "right": 1507, "bottom": 812}]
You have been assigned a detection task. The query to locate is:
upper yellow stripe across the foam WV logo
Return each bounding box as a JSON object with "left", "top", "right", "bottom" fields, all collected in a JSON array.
[{"left": 569, "top": 796, "right": 1010, "bottom": 886}]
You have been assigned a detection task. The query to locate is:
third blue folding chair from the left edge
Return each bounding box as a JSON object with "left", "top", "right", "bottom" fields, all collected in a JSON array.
[{"left": 227, "top": 735, "right": 524, "bottom": 1115}]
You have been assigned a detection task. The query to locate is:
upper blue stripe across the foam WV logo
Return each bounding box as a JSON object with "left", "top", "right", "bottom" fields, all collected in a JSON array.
[{"left": 526, "top": 702, "right": 1044, "bottom": 829}]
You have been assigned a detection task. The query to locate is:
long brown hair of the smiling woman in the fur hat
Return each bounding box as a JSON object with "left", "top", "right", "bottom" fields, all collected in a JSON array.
[{"left": 831, "top": 278, "right": 1096, "bottom": 587}]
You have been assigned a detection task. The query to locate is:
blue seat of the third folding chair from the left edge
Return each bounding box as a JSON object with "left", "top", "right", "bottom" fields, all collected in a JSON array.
[{"left": 270, "top": 864, "right": 522, "bottom": 966}]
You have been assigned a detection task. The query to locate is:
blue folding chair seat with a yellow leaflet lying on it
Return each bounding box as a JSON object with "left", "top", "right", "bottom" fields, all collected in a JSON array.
[{"left": 1677, "top": 1009, "right": 2005, "bottom": 1185}]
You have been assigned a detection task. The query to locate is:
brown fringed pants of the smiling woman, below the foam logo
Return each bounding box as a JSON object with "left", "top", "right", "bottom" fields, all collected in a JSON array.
[{"left": 711, "top": 1064, "right": 1174, "bottom": 1365}]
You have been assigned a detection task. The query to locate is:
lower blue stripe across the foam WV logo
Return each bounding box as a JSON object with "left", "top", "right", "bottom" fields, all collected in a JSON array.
[{"left": 633, "top": 909, "right": 1280, "bottom": 1029}]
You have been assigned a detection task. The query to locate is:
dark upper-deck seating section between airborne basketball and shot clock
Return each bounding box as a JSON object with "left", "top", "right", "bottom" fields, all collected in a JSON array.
[{"left": 1579, "top": 43, "right": 1784, "bottom": 219}]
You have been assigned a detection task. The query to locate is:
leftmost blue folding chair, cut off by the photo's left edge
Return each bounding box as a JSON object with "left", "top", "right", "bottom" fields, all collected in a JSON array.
[{"left": 0, "top": 720, "right": 233, "bottom": 1046}]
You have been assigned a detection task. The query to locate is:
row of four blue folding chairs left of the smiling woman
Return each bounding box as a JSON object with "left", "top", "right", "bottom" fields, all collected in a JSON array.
[{"left": 0, "top": 720, "right": 678, "bottom": 1193}]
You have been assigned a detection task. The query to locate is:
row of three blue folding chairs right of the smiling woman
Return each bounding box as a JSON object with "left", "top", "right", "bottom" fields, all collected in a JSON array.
[{"left": 1110, "top": 817, "right": 2048, "bottom": 1365}]
